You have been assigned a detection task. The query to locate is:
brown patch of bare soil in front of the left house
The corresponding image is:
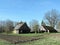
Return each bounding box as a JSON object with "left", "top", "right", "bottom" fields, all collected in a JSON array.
[{"left": 0, "top": 34, "right": 42, "bottom": 44}]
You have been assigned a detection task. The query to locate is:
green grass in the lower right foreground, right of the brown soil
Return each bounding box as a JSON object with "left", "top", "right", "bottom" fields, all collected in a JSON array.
[{"left": 20, "top": 33, "right": 60, "bottom": 45}]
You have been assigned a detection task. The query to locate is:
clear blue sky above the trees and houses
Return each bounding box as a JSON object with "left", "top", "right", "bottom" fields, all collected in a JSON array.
[{"left": 0, "top": 0, "right": 60, "bottom": 22}]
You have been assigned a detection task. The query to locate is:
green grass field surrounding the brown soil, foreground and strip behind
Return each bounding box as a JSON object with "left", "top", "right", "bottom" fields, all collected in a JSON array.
[{"left": 0, "top": 33, "right": 60, "bottom": 45}]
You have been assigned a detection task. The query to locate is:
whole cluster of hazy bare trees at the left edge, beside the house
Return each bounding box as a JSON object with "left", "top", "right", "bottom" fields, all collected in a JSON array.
[{"left": 0, "top": 20, "right": 17, "bottom": 33}]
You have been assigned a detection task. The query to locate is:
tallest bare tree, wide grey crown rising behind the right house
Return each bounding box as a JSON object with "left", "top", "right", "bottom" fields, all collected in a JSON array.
[{"left": 45, "top": 9, "right": 59, "bottom": 27}]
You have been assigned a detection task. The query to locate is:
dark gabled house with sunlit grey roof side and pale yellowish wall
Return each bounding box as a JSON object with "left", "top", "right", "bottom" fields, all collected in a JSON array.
[{"left": 13, "top": 22, "right": 30, "bottom": 34}]
